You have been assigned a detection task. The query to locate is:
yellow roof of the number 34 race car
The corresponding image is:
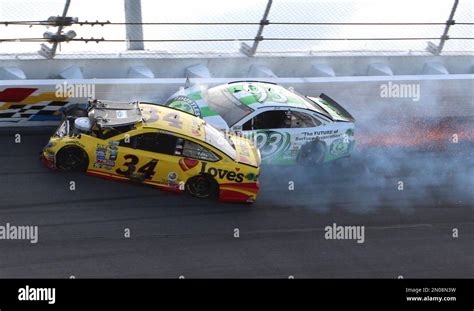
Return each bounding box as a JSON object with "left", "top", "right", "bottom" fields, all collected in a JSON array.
[{"left": 139, "top": 103, "right": 206, "bottom": 142}]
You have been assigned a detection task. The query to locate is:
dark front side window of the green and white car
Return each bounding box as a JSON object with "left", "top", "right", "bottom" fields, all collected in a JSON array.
[{"left": 242, "top": 110, "right": 291, "bottom": 131}]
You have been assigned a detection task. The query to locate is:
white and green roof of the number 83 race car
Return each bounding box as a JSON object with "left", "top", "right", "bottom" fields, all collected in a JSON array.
[{"left": 222, "top": 81, "right": 315, "bottom": 111}]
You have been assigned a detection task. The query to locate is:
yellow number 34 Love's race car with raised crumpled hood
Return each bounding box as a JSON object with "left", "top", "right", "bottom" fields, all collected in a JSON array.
[{"left": 42, "top": 100, "right": 261, "bottom": 202}]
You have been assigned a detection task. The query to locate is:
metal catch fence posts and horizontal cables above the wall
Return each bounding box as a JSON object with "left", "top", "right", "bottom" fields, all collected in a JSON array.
[{"left": 0, "top": 0, "right": 474, "bottom": 58}]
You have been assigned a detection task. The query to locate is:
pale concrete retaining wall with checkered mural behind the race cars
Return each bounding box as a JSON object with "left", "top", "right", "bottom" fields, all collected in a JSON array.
[{"left": 0, "top": 74, "right": 474, "bottom": 126}]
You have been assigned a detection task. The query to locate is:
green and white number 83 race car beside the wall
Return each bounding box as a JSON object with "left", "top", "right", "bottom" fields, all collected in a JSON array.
[{"left": 164, "top": 81, "right": 354, "bottom": 165}]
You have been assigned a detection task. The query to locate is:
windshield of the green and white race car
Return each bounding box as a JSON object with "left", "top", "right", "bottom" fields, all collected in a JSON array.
[{"left": 205, "top": 85, "right": 253, "bottom": 127}]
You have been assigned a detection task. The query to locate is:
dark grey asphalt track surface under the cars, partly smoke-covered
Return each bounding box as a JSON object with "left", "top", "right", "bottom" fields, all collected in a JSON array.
[{"left": 0, "top": 130, "right": 474, "bottom": 278}]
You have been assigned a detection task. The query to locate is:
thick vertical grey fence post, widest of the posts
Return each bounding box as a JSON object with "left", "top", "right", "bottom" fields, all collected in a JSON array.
[{"left": 124, "top": 0, "right": 145, "bottom": 50}]
